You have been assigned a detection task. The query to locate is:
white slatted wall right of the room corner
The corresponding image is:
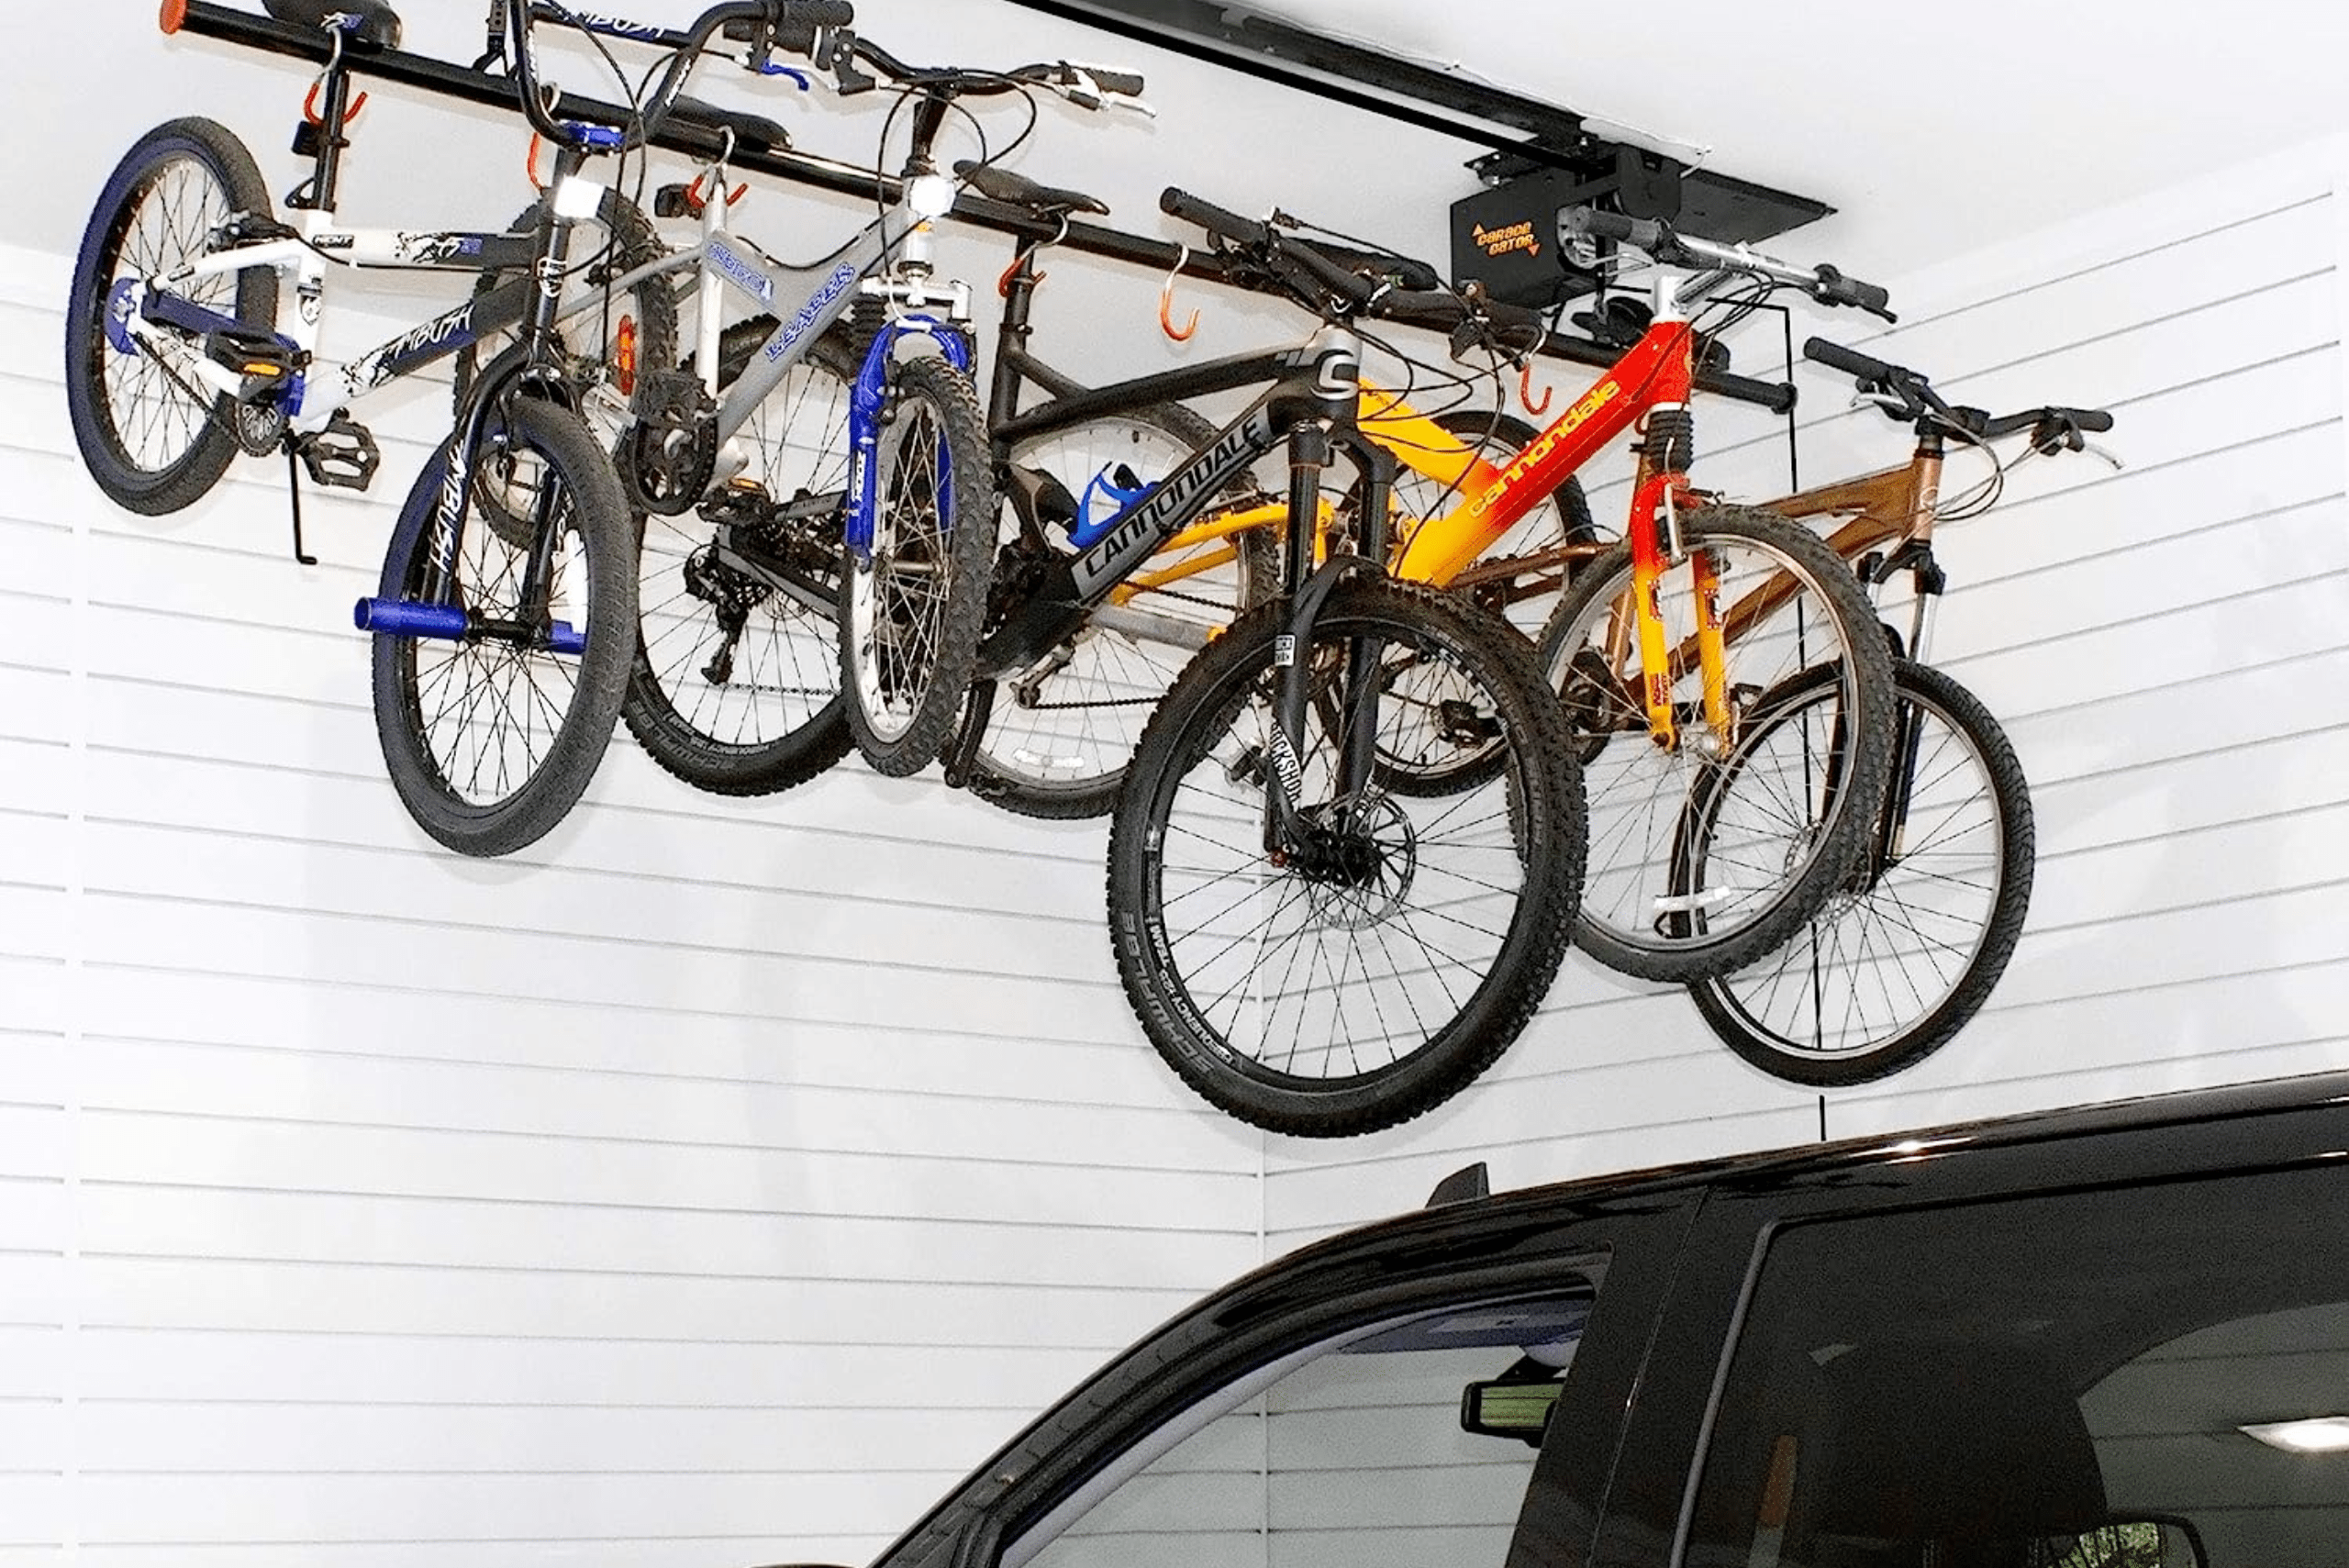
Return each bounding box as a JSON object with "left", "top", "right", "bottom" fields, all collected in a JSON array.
[{"left": 1266, "top": 148, "right": 2349, "bottom": 1251}]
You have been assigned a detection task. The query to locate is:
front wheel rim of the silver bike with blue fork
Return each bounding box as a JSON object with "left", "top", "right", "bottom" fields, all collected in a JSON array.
[{"left": 848, "top": 399, "right": 953, "bottom": 741}]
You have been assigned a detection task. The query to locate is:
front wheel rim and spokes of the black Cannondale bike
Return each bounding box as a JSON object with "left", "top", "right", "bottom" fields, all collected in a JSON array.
[{"left": 1144, "top": 634, "right": 1527, "bottom": 1089}]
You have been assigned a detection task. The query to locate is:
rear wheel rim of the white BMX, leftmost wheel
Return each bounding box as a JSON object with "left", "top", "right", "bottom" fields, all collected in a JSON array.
[{"left": 87, "top": 152, "right": 238, "bottom": 474}]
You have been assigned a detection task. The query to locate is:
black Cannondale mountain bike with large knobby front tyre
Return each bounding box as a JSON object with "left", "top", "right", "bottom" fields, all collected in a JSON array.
[{"left": 874, "top": 183, "right": 1583, "bottom": 1136}]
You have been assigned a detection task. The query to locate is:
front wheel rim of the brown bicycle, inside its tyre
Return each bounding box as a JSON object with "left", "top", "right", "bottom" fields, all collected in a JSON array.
[{"left": 1706, "top": 693, "right": 2006, "bottom": 1063}]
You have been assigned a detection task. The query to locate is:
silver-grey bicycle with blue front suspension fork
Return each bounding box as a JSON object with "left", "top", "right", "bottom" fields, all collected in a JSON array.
[{"left": 497, "top": 18, "right": 1141, "bottom": 795}]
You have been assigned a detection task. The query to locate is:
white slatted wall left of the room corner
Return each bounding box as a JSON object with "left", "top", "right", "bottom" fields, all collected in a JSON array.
[{"left": 0, "top": 226, "right": 1259, "bottom": 1568}]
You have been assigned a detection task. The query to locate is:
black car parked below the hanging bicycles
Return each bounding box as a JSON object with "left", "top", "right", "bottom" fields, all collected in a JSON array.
[{"left": 845, "top": 1075, "right": 2349, "bottom": 1568}]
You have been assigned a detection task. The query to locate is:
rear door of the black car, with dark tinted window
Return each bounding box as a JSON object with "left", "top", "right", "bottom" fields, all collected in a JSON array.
[{"left": 1595, "top": 1089, "right": 2349, "bottom": 1568}]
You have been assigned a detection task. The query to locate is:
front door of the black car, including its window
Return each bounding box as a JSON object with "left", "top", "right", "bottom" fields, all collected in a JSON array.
[{"left": 876, "top": 1190, "right": 1696, "bottom": 1568}]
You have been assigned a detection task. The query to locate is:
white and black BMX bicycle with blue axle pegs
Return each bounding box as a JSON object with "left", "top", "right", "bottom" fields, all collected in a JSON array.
[{"left": 66, "top": 0, "right": 851, "bottom": 854}]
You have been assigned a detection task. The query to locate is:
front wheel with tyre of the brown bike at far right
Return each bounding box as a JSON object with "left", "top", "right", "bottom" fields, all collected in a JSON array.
[{"left": 1689, "top": 660, "right": 2032, "bottom": 1087}]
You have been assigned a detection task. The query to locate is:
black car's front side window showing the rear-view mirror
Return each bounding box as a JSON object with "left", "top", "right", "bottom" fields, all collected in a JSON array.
[{"left": 1003, "top": 1261, "right": 1602, "bottom": 1568}]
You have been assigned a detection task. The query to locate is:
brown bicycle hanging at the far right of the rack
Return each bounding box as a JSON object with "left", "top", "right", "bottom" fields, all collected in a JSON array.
[{"left": 1687, "top": 338, "right": 2111, "bottom": 1087}]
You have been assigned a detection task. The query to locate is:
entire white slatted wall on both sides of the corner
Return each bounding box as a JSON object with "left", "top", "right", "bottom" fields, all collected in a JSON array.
[{"left": 14, "top": 7, "right": 2349, "bottom": 1568}]
